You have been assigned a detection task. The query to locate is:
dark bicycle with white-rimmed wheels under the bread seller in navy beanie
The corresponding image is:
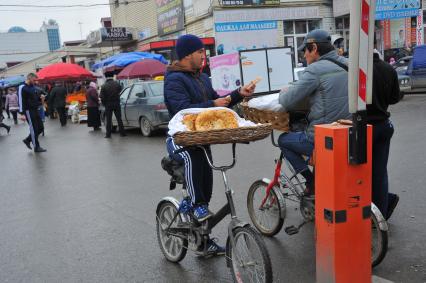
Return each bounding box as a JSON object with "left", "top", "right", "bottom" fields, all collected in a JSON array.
[{"left": 156, "top": 143, "right": 273, "bottom": 282}]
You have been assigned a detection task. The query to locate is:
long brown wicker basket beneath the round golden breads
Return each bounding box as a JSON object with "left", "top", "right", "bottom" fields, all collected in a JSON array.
[{"left": 173, "top": 124, "right": 272, "bottom": 146}]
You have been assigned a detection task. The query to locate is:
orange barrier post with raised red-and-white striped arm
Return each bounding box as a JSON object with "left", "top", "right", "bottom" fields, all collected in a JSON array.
[{"left": 315, "top": 0, "right": 375, "bottom": 283}]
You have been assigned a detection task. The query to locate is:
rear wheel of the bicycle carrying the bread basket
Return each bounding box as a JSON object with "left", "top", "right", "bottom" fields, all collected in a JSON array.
[{"left": 157, "top": 201, "right": 188, "bottom": 262}]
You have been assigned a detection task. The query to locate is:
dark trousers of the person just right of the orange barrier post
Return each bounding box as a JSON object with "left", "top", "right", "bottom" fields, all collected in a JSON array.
[{"left": 372, "top": 120, "right": 395, "bottom": 218}]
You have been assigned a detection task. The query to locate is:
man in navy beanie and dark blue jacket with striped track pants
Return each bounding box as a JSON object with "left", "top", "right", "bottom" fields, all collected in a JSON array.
[{"left": 164, "top": 34, "right": 255, "bottom": 255}]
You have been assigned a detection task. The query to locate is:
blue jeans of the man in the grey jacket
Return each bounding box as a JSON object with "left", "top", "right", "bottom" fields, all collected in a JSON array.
[{"left": 278, "top": 132, "right": 314, "bottom": 185}]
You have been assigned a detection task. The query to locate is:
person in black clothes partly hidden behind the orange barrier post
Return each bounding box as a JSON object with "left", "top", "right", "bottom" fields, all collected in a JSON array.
[{"left": 367, "top": 52, "right": 401, "bottom": 219}]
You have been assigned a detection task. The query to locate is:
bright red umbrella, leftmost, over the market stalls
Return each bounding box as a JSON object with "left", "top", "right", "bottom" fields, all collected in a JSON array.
[{"left": 37, "top": 63, "right": 95, "bottom": 81}]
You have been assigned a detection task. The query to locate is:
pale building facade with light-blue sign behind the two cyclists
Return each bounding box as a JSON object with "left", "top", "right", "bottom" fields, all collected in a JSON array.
[{"left": 106, "top": 0, "right": 335, "bottom": 63}]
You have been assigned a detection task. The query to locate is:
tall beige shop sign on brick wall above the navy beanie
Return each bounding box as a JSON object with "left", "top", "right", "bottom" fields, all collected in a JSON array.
[{"left": 155, "top": 0, "right": 184, "bottom": 36}]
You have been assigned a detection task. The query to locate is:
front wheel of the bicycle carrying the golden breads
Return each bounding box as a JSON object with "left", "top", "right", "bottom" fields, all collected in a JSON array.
[{"left": 230, "top": 227, "right": 273, "bottom": 283}]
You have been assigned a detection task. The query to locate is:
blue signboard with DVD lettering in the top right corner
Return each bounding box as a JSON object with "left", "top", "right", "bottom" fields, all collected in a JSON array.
[{"left": 376, "top": 0, "right": 420, "bottom": 20}]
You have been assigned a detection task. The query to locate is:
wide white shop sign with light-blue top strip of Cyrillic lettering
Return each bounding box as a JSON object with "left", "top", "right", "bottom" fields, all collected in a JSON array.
[{"left": 215, "top": 21, "right": 278, "bottom": 55}]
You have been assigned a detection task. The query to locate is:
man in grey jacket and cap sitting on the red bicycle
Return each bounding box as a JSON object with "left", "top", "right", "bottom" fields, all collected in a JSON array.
[{"left": 278, "top": 30, "right": 350, "bottom": 195}]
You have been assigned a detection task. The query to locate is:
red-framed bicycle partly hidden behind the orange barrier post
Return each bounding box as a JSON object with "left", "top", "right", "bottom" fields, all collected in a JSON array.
[{"left": 247, "top": 132, "right": 388, "bottom": 267}]
